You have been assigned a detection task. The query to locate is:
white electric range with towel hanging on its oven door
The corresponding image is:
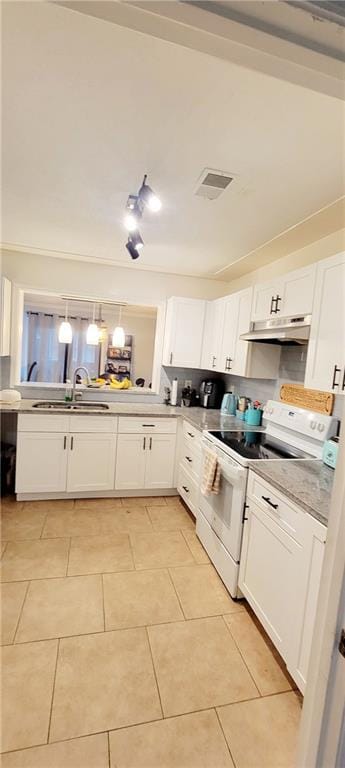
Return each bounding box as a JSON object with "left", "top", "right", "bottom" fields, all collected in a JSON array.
[{"left": 196, "top": 400, "right": 338, "bottom": 597}]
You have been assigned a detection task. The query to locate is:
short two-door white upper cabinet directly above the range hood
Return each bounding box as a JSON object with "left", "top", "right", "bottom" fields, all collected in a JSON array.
[{"left": 251, "top": 264, "right": 315, "bottom": 321}]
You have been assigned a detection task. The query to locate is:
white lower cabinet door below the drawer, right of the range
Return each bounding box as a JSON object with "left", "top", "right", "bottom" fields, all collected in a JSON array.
[{"left": 239, "top": 502, "right": 301, "bottom": 660}]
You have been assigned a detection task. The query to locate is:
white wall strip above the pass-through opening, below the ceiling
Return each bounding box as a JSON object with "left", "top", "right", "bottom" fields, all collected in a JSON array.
[{"left": 2, "top": 250, "right": 227, "bottom": 304}]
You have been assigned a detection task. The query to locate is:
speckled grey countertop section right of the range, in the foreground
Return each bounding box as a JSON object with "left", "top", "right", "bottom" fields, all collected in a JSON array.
[{"left": 250, "top": 459, "right": 334, "bottom": 525}]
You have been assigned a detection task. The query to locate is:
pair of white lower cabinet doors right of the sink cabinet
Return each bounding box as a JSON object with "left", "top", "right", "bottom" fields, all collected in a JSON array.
[{"left": 115, "top": 433, "right": 176, "bottom": 490}]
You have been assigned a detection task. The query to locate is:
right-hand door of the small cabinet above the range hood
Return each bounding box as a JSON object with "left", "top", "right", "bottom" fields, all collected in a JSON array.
[{"left": 277, "top": 264, "right": 316, "bottom": 317}]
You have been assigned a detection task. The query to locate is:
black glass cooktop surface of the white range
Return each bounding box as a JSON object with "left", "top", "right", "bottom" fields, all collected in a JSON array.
[{"left": 209, "top": 431, "right": 313, "bottom": 459}]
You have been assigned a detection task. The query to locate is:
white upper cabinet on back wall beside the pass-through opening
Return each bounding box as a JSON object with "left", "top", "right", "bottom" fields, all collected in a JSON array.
[{"left": 163, "top": 297, "right": 206, "bottom": 368}]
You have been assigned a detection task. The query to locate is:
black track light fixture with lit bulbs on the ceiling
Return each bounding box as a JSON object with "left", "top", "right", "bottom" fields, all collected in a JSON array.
[{"left": 124, "top": 173, "right": 162, "bottom": 259}]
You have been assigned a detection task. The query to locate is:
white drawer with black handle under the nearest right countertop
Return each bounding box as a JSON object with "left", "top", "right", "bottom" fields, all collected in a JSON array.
[{"left": 247, "top": 472, "right": 306, "bottom": 542}]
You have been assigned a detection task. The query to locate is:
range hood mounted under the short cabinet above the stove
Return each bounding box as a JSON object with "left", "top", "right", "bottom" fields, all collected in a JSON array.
[{"left": 240, "top": 315, "right": 311, "bottom": 346}]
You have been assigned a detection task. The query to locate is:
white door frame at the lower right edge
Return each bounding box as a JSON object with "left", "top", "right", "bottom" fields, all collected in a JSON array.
[{"left": 296, "top": 398, "right": 345, "bottom": 768}]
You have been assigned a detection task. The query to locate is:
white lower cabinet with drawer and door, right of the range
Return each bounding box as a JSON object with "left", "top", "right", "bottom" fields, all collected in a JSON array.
[{"left": 239, "top": 472, "right": 326, "bottom": 693}]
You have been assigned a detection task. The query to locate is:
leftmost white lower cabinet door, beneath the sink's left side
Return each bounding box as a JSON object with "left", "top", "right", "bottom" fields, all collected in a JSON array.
[{"left": 16, "top": 432, "right": 68, "bottom": 493}]
